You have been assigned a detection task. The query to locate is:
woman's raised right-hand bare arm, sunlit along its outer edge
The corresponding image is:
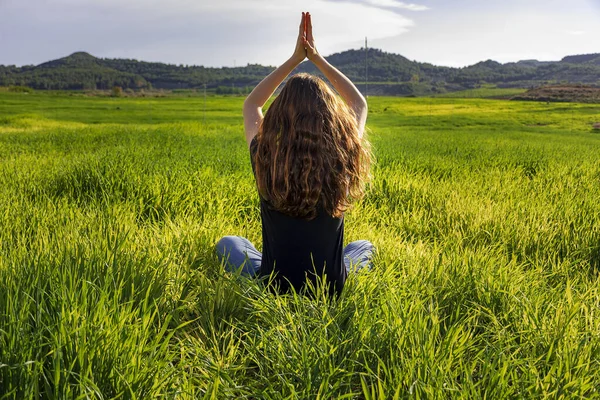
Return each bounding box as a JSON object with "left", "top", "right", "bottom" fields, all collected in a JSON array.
[{"left": 304, "top": 13, "right": 368, "bottom": 137}]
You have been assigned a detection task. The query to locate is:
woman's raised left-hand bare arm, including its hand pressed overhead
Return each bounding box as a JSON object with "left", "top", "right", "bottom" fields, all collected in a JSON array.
[{"left": 243, "top": 13, "right": 306, "bottom": 147}]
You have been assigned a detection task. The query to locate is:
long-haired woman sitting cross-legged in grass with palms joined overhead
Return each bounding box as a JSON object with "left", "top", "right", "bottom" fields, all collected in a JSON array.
[{"left": 217, "top": 13, "right": 373, "bottom": 293}]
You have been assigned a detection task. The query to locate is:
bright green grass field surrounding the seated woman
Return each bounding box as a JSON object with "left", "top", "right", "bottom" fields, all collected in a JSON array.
[{"left": 0, "top": 93, "right": 600, "bottom": 399}]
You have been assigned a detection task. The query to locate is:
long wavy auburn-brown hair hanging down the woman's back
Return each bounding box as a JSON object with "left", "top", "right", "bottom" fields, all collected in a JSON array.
[{"left": 254, "top": 74, "right": 371, "bottom": 220}]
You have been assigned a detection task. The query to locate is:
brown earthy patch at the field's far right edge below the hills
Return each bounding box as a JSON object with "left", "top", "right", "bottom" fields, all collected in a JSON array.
[{"left": 512, "top": 85, "right": 600, "bottom": 103}]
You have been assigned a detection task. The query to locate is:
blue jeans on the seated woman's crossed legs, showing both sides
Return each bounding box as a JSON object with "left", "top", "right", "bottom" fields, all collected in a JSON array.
[{"left": 216, "top": 236, "right": 375, "bottom": 276}]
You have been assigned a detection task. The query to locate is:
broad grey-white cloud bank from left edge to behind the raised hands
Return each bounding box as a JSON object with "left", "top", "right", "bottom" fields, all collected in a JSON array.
[{"left": 0, "top": 0, "right": 418, "bottom": 66}]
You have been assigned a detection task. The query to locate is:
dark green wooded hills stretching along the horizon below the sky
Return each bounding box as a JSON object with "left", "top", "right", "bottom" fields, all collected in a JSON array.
[{"left": 0, "top": 49, "right": 600, "bottom": 95}]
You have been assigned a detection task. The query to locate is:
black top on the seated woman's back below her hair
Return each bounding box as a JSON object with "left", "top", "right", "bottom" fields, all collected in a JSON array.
[{"left": 250, "top": 138, "right": 347, "bottom": 294}]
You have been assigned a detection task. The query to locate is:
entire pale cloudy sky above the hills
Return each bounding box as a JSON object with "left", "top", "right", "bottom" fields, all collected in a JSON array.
[{"left": 0, "top": 0, "right": 600, "bottom": 67}]
